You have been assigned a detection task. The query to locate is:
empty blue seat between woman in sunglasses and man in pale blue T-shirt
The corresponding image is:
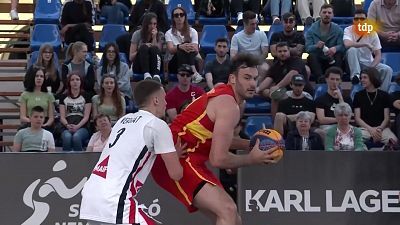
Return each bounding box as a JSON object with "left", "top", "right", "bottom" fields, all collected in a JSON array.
[{"left": 200, "top": 25, "right": 228, "bottom": 55}]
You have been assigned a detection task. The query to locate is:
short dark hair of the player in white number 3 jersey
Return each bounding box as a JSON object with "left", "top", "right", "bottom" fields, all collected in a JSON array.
[{"left": 133, "top": 80, "right": 162, "bottom": 108}]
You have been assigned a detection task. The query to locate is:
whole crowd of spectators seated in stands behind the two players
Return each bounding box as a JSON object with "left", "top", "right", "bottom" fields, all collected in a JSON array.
[{"left": 9, "top": 0, "right": 400, "bottom": 151}]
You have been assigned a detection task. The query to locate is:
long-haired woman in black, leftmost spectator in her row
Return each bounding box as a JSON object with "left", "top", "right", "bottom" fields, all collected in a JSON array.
[{"left": 24, "top": 44, "right": 63, "bottom": 96}]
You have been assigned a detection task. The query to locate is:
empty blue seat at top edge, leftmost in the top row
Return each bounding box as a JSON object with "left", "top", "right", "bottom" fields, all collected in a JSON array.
[{"left": 33, "top": 0, "right": 62, "bottom": 24}]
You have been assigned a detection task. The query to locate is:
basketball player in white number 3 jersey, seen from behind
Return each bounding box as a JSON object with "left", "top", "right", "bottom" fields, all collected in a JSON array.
[{"left": 80, "top": 80, "right": 183, "bottom": 225}]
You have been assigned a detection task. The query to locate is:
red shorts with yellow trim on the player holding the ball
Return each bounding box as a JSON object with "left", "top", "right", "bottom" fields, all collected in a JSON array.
[{"left": 152, "top": 148, "right": 223, "bottom": 212}]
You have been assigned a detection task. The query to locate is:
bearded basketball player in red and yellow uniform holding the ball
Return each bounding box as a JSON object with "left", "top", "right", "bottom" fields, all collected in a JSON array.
[{"left": 152, "top": 54, "right": 282, "bottom": 225}]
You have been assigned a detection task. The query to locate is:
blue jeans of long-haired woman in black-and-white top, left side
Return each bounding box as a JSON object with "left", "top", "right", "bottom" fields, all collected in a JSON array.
[{"left": 62, "top": 128, "right": 89, "bottom": 151}]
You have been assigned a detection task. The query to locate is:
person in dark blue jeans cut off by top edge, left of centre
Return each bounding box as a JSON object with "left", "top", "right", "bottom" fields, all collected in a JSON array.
[{"left": 99, "top": 0, "right": 129, "bottom": 24}]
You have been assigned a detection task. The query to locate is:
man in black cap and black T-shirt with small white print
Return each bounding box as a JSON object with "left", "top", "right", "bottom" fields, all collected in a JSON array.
[{"left": 274, "top": 74, "right": 315, "bottom": 135}]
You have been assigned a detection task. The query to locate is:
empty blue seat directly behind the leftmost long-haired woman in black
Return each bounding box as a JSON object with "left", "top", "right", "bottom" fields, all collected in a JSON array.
[{"left": 31, "top": 24, "right": 61, "bottom": 52}]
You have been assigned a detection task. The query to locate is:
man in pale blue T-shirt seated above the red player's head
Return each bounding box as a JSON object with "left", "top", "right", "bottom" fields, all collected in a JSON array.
[{"left": 230, "top": 11, "right": 269, "bottom": 79}]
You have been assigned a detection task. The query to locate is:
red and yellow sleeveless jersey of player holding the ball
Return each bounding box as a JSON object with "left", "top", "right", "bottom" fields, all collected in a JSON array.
[{"left": 170, "top": 84, "right": 239, "bottom": 161}]
